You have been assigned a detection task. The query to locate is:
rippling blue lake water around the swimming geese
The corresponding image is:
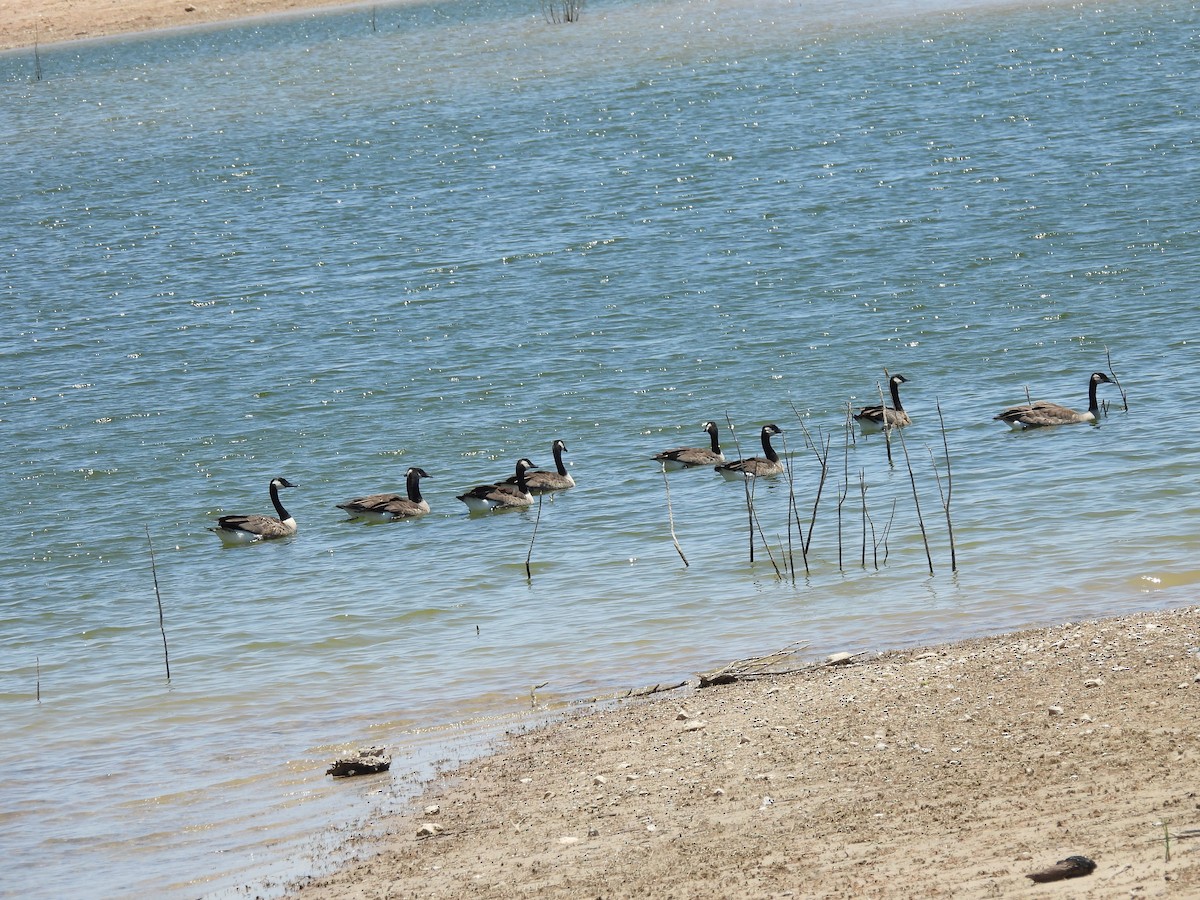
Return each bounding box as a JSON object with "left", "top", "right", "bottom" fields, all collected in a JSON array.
[{"left": 0, "top": 0, "right": 1200, "bottom": 898}]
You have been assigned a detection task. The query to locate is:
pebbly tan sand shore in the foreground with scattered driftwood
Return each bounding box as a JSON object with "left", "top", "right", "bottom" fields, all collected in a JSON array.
[{"left": 285, "top": 607, "right": 1200, "bottom": 899}]
